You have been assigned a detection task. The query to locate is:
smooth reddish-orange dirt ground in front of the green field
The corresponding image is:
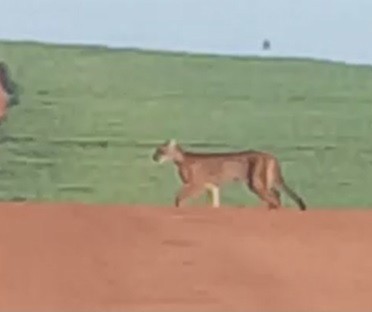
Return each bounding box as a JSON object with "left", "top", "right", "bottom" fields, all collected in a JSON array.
[{"left": 0, "top": 204, "right": 372, "bottom": 312}]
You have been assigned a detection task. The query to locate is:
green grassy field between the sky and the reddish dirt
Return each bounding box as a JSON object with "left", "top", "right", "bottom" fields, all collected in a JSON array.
[{"left": 0, "top": 42, "right": 372, "bottom": 207}]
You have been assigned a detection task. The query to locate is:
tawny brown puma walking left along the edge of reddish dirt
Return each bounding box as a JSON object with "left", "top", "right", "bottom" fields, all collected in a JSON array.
[{"left": 153, "top": 140, "right": 306, "bottom": 210}]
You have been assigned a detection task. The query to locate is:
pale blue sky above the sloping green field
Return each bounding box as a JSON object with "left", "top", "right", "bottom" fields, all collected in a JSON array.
[{"left": 0, "top": 0, "right": 372, "bottom": 64}]
